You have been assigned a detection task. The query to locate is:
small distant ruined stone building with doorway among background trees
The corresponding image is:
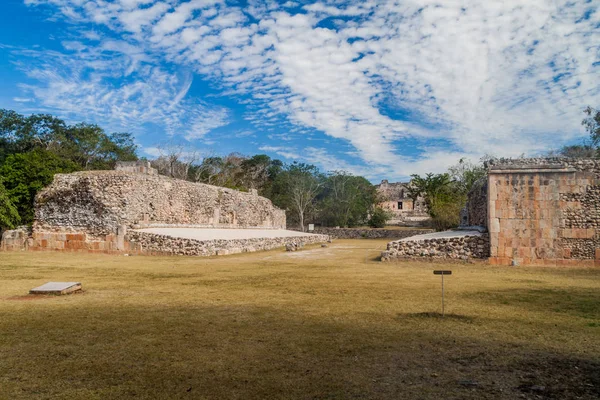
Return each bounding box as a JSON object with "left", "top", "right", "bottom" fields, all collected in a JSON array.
[{"left": 376, "top": 180, "right": 429, "bottom": 226}]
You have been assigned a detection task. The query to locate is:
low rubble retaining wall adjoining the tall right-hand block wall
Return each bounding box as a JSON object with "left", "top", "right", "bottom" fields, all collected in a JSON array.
[{"left": 381, "top": 234, "right": 490, "bottom": 261}]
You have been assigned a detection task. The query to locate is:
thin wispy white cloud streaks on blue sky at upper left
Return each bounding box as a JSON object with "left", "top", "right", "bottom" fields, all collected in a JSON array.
[{"left": 14, "top": 41, "right": 230, "bottom": 140}]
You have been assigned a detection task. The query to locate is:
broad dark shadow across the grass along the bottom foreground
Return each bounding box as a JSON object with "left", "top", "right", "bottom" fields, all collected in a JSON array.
[{"left": 0, "top": 304, "right": 600, "bottom": 399}]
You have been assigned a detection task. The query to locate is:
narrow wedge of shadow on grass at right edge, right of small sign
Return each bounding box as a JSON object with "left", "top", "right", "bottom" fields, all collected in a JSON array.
[{"left": 467, "top": 288, "right": 600, "bottom": 319}]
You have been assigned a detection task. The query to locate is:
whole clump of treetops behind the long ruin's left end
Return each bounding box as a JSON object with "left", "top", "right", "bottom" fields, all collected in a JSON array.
[{"left": 0, "top": 109, "right": 137, "bottom": 228}]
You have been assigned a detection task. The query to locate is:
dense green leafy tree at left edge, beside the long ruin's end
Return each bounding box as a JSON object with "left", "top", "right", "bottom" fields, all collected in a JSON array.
[{"left": 0, "top": 149, "right": 79, "bottom": 224}]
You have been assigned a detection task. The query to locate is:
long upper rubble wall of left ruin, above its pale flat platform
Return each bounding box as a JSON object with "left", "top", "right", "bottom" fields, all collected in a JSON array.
[{"left": 34, "top": 171, "right": 286, "bottom": 238}]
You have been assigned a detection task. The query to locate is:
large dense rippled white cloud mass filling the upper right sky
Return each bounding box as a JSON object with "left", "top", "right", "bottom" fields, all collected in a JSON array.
[{"left": 17, "top": 0, "right": 600, "bottom": 176}]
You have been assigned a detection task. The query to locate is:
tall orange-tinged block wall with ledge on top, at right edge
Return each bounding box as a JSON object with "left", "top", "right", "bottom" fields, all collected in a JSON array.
[{"left": 488, "top": 158, "right": 600, "bottom": 266}]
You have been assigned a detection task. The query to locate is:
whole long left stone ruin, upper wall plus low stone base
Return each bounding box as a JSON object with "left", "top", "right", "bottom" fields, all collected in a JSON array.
[{"left": 2, "top": 166, "right": 329, "bottom": 256}]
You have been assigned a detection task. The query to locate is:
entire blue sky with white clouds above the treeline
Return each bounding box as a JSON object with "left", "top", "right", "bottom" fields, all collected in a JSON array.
[{"left": 0, "top": 0, "right": 600, "bottom": 182}]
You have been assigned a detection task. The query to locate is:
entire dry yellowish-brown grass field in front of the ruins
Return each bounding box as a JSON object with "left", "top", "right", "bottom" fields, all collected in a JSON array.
[{"left": 0, "top": 240, "right": 600, "bottom": 399}]
